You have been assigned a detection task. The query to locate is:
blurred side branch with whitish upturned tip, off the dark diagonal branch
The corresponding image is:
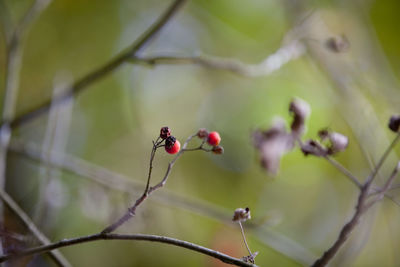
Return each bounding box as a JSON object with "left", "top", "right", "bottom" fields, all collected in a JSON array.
[{"left": 131, "top": 40, "right": 305, "bottom": 77}]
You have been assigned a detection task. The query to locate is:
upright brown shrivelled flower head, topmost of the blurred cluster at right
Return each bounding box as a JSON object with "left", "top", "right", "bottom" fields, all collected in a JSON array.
[{"left": 289, "top": 98, "right": 311, "bottom": 137}]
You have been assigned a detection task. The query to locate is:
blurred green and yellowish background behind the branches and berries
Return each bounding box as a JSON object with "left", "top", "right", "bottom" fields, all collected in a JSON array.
[{"left": 0, "top": 0, "right": 400, "bottom": 266}]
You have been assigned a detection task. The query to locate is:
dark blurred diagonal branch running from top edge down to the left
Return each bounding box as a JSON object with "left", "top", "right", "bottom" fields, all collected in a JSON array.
[{"left": 11, "top": 0, "right": 186, "bottom": 128}]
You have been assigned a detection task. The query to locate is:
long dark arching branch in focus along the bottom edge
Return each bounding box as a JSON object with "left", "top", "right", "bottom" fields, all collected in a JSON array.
[{"left": 0, "top": 233, "right": 257, "bottom": 267}]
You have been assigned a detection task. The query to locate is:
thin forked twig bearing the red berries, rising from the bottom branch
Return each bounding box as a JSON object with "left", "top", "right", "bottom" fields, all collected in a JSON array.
[{"left": 101, "top": 134, "right": 197, "bottom": 233}]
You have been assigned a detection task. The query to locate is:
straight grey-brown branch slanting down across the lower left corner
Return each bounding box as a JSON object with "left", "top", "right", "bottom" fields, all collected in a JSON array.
[{"left": 0, "top": 189, "right": 71, "bottom": 266}]
